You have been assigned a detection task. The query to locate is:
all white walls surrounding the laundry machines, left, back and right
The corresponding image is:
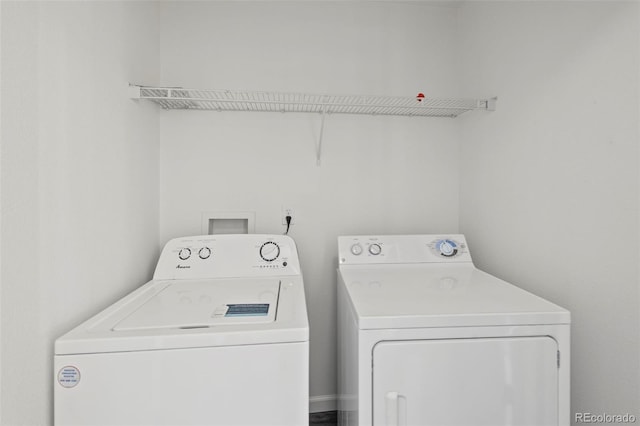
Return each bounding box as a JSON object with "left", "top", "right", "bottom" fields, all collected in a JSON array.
[{"left": 0, "top": 1, "right": 640, "bottom": 425}]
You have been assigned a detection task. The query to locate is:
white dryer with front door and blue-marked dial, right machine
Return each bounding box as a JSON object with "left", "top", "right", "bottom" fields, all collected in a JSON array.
[{"left": 338, "top": 235, "right": 570, "bottom": 426}]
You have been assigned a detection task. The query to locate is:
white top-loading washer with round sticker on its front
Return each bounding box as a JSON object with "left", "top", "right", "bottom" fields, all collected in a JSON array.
[{"left": 54, "top": 234, "right": 309, "bottom": 426}]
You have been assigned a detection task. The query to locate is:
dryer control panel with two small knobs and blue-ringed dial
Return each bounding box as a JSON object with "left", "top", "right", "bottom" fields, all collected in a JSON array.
[{"left": 338, "top": 234, "right": 472, "bottom": 265}]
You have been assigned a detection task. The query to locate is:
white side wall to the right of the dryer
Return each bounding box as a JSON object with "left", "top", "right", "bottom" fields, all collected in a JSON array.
[{"left": 458, "top": 2, "right": 640, "bottom": 422}]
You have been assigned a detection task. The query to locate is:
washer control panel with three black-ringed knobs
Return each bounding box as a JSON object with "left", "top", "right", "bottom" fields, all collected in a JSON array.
[{"left": 153, "top": 234, "right": 300, "bottom": 280}]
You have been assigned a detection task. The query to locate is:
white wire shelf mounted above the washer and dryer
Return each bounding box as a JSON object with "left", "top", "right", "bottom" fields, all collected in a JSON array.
[{"left": 132, "top": 86, "right": 495, "bottom": 118}]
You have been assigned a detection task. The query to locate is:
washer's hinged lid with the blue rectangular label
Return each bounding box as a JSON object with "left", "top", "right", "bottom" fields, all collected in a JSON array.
[{"left": 113, "top": 279, "right": 280, "bottom": 331}]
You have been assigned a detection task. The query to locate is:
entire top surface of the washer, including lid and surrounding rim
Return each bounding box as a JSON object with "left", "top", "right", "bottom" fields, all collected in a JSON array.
[{"left": 55, "top": 276, "right": 309, "bottom": 355}]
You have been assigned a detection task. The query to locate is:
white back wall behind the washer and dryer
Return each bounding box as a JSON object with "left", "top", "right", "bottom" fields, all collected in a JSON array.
[{"left": 160, "top": 2, "right": 458, "bottom": 410}]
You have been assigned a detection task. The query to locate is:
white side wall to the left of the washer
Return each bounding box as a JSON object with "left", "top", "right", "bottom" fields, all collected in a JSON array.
[{"left": 0, "top": 1, "right": 159, "bottom": 425}]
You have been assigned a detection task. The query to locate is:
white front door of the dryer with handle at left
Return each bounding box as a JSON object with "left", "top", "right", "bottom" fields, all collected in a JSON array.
[{"left": 373, "top": 336, "right": 558, "bottom": 426}]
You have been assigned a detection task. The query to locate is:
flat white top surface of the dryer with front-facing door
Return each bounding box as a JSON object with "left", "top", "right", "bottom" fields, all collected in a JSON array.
[{"left": 340, "top": 265, "right": 570, "bottom": 329}]
